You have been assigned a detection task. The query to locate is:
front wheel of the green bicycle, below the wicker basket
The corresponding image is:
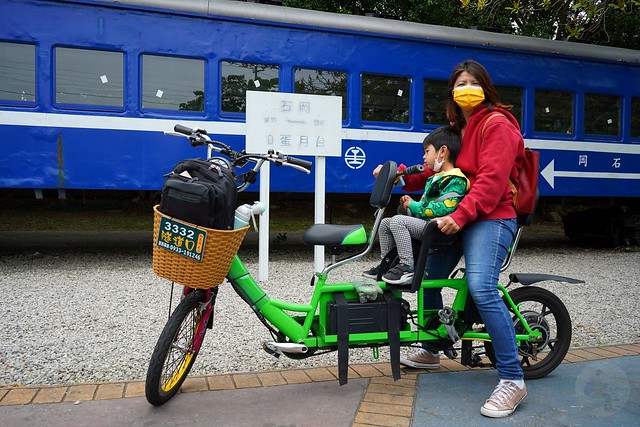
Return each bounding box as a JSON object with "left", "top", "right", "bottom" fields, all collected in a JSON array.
[{"left": 145, "top": 291, "right": 207, "bottom": 406}]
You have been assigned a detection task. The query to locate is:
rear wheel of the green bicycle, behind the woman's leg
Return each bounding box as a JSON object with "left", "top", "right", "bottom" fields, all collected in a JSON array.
[{"left": 484, "top": 286, "right": 572, "bottom": 380}]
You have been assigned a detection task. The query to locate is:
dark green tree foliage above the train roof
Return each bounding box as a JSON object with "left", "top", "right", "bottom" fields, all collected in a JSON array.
[{"left": 282, "top": 0, "right": 640, "bottom": 49}]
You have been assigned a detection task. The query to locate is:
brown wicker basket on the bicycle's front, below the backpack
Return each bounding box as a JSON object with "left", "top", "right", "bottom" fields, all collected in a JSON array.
[{"left": 153, "top": 205, "right": 249, "bottom": 289}]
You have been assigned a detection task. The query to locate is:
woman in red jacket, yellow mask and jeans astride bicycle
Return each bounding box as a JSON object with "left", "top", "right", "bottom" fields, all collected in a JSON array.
[{"left": 400, "top": 60, "right": 527, "bottom": 418}]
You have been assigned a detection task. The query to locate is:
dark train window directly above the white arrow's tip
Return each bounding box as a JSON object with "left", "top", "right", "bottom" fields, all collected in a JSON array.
[{"left": 534, "top": 89, "right": 575, "bottom": 134}]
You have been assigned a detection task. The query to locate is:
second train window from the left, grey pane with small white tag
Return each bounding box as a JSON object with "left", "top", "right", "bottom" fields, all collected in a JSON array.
[{"left": 55, "top": 47, "right": 124, "bottom": 107}]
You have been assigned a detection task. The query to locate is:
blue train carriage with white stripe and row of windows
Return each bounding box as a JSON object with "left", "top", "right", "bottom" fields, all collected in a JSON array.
[{"left": 0, "top": 0, "right": 640, "bottom": 237}]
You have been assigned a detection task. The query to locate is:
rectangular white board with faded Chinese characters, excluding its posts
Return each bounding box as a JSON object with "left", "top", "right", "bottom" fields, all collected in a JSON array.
[{"left": 246, "top": 91, "right": 342, "bottom": 157}]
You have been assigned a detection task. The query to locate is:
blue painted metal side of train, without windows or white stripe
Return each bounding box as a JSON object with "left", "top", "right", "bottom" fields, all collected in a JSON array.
[{"left": 0, "top": 0, "right": 640, "bottom": 197}]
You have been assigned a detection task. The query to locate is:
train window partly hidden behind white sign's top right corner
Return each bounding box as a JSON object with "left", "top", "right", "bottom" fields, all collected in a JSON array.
[{"left": 293, "top": 68, "right": 347, "bottom": 120}]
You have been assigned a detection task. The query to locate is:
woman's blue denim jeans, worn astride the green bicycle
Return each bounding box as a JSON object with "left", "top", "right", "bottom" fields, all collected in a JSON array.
[{"left": 425, "top": 219, "right": 524, "bottom": 380}]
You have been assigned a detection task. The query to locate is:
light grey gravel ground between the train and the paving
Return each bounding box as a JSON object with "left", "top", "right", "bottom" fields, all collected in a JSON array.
[{"left": 0, "top": 235, "right": 640, "bottom": 385}]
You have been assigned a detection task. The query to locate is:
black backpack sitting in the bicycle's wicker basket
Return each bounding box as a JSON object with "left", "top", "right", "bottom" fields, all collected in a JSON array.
[{"left": 160, "top": 159, "right": 237, "bottom": 230}]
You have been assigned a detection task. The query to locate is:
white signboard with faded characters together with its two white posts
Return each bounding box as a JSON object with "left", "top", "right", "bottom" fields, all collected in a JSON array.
[{"left": 246, "top": 91, "right": 342, "bottom": 281}]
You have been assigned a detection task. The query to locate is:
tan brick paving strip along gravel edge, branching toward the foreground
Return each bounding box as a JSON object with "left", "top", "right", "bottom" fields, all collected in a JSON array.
[{"left": 0, "top": 344, "right": 640, "bottom": 426}]
